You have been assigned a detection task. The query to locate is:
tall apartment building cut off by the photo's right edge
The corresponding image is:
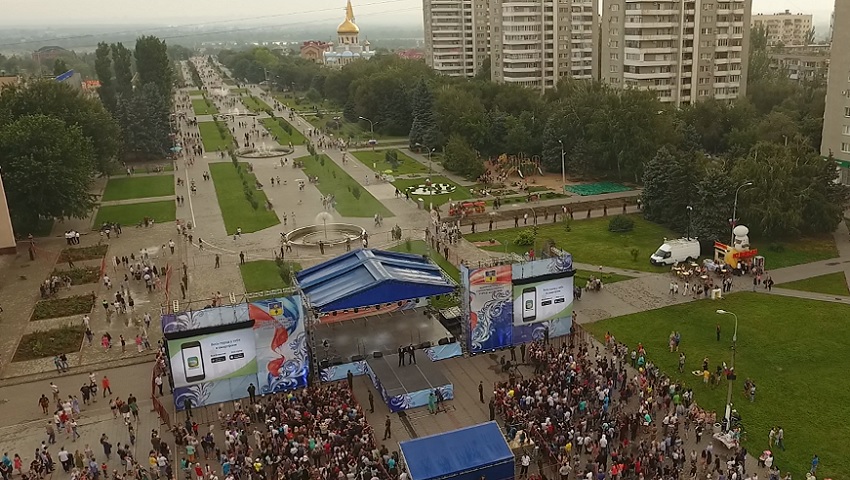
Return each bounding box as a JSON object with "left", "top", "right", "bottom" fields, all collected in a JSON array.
[{"left": 820, "top": 0, "right": 850, "bottom": 184}]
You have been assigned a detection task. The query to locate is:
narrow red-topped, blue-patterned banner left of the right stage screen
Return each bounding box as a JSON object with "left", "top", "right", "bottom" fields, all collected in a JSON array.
[{"left": 465, "top": 265, "right": 513, "bottom": 353}]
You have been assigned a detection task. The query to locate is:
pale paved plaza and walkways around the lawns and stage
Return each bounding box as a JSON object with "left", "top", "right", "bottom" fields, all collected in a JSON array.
[{"left": 0, "top": 59, "right": 850, "bottom": 478}]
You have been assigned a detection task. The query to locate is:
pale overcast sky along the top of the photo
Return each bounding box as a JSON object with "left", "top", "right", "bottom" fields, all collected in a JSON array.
[{"left": 0, "top": 0, "right": 836, "bottom": 27}]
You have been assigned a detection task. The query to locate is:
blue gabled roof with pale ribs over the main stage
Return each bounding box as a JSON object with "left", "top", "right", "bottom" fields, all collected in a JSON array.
[{"left": 295, "top": 250, "right": 455, "bottom": 312}]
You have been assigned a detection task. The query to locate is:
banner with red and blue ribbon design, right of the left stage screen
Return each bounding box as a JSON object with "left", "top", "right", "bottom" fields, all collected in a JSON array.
[{"left": 248, "top": 295, "right": 310, "bottom": 395}]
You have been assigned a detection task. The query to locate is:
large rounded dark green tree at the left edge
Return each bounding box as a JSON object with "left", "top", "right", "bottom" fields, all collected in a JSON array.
[{"left": 0, "top": 114, "right": 95, "bottom": 232}]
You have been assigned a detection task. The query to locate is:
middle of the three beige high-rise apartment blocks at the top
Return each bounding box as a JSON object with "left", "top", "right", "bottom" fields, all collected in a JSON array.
[{"left": 490, "top": 0, "right": 599, "bottom": 88}]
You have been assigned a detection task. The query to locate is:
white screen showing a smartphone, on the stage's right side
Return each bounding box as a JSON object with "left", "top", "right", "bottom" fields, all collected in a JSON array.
[{"left": 511, "top": 253, "right": 575, "bottom": 345}]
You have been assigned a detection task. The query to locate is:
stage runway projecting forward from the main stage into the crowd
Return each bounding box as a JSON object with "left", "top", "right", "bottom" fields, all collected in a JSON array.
[{"left": 366, "top": 350, "right": 454, "bottom": 413}]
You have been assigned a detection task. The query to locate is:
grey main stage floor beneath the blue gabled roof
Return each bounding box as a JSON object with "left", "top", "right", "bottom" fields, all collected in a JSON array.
[{"left": 313, "top": 308, "right": 451, "bottom": 364}]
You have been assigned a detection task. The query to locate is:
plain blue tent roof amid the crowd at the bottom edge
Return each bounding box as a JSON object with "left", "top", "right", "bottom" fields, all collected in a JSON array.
[{"left": 399, "top": 422, "right": 514, "bottom": 480}]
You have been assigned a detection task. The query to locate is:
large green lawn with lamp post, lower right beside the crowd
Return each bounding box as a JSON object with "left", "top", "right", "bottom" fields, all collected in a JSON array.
[{"left": 585, "top": 293, "right": 850, "bottom": 478}]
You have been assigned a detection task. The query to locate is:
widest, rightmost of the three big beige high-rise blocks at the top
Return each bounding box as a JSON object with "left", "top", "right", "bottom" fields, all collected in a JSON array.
[{"left": 599, "top": 0, "right": 752, "bottom": 106}]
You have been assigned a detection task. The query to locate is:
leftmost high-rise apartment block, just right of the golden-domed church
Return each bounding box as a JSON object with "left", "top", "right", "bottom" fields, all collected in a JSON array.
[{"left": 423, "top": 0, "right": 490, "bottom": 77}]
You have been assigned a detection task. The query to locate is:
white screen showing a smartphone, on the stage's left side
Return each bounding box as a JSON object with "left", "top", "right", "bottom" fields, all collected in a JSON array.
[{"left": 168, "top": 328, "right": 257, "bottom": 410}]
